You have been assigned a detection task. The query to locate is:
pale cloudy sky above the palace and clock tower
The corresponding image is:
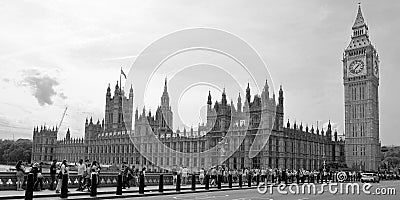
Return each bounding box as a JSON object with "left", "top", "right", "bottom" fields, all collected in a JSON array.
[{"left": 0, "top": 0, "right": 400, "bottom": 145}]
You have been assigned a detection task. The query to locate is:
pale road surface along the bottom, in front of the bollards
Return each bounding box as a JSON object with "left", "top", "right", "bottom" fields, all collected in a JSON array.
[{"left": 0, "top": 181, "right": 400, "bottom": 200}]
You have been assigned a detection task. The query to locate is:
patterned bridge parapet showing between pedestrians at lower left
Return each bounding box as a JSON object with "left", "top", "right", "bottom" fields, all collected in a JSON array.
[{"left": 0, "top": 172, "right": 172, "bottom": 190}]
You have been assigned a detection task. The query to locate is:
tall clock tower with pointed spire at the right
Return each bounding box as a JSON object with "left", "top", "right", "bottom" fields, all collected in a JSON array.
[{"left": 343, "top": 5, "right": 380, "bottom": 171}]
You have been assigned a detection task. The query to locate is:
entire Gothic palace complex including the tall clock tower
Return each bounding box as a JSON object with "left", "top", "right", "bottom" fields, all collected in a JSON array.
[{"left": 32, "top": 6, "right": 380, "bottom": 172}]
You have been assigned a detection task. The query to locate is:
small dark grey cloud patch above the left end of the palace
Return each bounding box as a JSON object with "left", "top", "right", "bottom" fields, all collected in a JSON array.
[{"left": 21, "top": 69, "right": 67, "bottom": 106}]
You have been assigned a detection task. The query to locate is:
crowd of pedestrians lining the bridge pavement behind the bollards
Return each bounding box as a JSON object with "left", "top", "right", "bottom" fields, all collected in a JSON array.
[{"left": 15, "top": 159, "right": 399, "bottom": 193}]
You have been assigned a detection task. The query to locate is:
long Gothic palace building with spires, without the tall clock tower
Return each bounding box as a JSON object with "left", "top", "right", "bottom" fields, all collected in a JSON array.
[{"left": 33, "top": 79, "right": 344, "bottom": 171}]
